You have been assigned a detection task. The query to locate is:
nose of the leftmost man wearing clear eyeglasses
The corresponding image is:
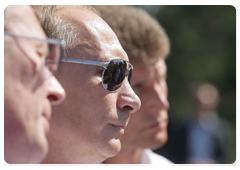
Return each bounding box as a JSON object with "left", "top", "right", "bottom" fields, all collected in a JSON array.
[{"left": 47, "top": 76, "right": 66, "bottom": 105}]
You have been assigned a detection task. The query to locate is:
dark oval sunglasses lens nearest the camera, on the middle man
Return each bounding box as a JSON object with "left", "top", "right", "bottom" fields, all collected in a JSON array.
[{"left": 103, "top": 59, "right": 127, "bottom": 91}]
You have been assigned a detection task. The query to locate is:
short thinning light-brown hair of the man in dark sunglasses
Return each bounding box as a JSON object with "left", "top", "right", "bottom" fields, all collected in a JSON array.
[{"left": 32, "top": 5, "right": 99, "bottom": 56}]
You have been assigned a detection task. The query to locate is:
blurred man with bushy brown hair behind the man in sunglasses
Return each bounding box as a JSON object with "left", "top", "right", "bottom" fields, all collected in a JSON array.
[{"left": 94, "top": 6, "right": 175, "bottom": 166}]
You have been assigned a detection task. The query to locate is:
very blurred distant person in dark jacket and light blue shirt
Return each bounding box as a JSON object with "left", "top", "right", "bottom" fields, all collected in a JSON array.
[{"left": 158, "top": 82, "right": 233, "bottom": 166}]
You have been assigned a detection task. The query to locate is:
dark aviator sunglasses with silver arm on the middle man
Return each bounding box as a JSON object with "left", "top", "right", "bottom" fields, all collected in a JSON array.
[{"left": 61, "top": 58, "right": 133, "bottom": 92}]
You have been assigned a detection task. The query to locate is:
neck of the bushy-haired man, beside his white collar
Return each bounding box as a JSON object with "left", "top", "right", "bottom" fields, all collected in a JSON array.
[{"left": 103, "top": 148, "right": 142, "bottom": 166}]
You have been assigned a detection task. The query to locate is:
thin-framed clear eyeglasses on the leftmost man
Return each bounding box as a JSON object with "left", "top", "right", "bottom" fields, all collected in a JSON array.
[{"left": 4, "top": 31, "right": 65, "bottom": 74}]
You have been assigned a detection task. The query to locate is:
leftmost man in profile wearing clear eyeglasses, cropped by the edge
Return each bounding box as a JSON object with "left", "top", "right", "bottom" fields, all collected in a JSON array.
[{"left": 4, "top": 5, "right": 66, "bottom": 165}]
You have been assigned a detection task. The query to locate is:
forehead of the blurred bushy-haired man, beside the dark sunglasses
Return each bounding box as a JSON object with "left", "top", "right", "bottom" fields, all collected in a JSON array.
[{"left": 132, "top": 59, "right": 167, "bottom": 83}]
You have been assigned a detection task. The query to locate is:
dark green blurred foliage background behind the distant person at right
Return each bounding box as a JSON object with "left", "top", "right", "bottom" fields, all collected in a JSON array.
[{"left": 136, "top": 5, "right": 238, "bottom": 165}]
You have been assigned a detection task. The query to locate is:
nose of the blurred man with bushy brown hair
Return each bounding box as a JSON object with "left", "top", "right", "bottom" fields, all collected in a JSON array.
[{"left": 149, "top": 82, "right": 170, "bottom": 109}]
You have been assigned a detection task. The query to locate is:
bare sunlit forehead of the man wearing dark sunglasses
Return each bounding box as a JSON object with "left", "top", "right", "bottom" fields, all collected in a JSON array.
[{"left": 61, "top": 8, "right": 128, "bottom": 61}]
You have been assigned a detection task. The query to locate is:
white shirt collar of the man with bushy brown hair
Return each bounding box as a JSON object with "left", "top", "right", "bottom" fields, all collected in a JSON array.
[{"left": 95, "top": 149, "right": 176, "bottom": 166}]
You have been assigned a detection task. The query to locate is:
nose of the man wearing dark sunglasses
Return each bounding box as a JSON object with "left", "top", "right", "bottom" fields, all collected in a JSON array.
[{"left": 117, "top": 79, "right": 141, "bottom": 114}]
